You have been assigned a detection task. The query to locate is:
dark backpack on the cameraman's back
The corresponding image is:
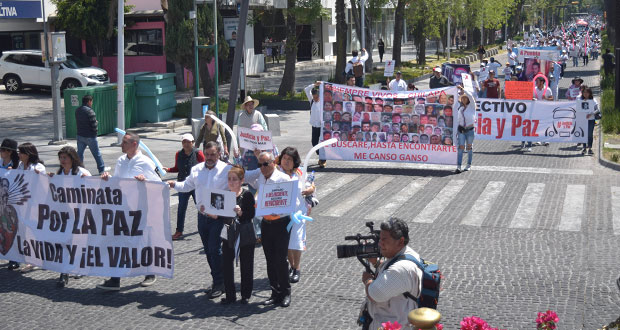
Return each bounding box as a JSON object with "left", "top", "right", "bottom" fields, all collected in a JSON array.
[{"left": 384, "top": 254, "right": 441, "bottom": 309}]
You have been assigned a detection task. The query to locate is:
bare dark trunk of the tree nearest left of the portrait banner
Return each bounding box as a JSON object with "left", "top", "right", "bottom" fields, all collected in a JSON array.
[{"left": 278, "top": 0, "right": 297, "bottom": 97}]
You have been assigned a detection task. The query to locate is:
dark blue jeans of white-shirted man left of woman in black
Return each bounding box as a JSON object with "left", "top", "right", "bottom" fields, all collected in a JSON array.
[{"left": 198, "top": 213, "right": 224, "bottom": 286}]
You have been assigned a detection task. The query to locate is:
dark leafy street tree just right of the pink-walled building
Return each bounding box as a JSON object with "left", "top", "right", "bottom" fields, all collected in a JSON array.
[{"left": 164, "top": 0, "right": 229, "bottom": 96}]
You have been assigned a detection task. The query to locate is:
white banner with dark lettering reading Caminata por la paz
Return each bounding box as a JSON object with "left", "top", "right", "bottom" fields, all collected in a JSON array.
[{"left": 0, "top": 170, "right": 174, "bottom": 278}]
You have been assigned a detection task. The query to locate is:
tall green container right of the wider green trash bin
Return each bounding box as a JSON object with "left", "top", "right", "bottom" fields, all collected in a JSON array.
[{"left": 136, "top": 73, "right": 177, "bottom": 123}]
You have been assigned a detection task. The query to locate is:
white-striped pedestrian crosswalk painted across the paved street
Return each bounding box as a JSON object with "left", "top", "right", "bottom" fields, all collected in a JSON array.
[{"left": 313, "top": 173, "right": 620, "bottom": 236}]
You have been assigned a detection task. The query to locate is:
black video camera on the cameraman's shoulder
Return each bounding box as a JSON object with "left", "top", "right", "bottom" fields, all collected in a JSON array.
[{"left": 336, "top": 221, "right": 381, "bottom": 275}]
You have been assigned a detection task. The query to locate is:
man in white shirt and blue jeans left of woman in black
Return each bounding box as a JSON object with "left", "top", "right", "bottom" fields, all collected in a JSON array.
[{"left": 168, "top": 141, "right": 231, "bottom": 299}]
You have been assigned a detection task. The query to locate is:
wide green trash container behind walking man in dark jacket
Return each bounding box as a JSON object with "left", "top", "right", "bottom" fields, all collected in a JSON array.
[{"left": 65, "top": 83, "right": 137, "bottom": 138}]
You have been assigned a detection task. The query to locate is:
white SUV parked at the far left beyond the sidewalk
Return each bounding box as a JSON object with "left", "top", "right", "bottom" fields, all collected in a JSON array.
[{"left": 0, "top": 50, "right": 110, "bottom": 93}]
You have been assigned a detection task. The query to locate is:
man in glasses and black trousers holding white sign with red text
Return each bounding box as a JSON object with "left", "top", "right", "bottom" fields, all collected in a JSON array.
[{"left": 245, "top": 151, "right": 291, "bottom": 307}]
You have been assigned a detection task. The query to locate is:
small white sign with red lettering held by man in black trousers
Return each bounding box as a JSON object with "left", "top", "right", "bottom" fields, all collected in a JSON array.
[{"left": 256, "top": 180, "right": 299, "bottom": 217}]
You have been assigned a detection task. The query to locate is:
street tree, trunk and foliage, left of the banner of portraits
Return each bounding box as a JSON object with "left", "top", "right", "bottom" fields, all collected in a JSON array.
[{"left": 278, "top": 0, "right": 326, "bottom": 96}]
